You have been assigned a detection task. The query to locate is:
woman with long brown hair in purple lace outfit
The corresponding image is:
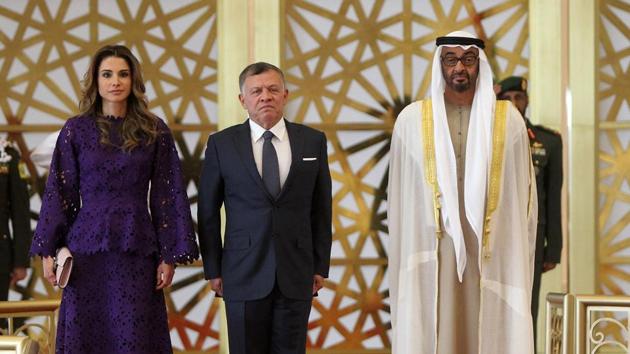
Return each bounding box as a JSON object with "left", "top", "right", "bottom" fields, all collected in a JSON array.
[{"left": 31, "top": 45, "right": 198, "bottom": 354}]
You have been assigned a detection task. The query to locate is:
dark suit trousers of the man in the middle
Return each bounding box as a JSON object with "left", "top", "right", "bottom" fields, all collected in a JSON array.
[{"left": 225, "top": 282, "right": 312, "bottom": 354}]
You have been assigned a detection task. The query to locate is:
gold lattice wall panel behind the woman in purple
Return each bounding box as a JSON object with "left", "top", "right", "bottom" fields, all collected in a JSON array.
[{"left": 0, "top": 0, "right": 219, "bottom": 351}]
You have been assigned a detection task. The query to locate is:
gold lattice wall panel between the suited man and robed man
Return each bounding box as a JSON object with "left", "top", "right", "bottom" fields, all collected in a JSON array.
[{"left": 283, "top": 0, "right": 529, "bottom": 353}]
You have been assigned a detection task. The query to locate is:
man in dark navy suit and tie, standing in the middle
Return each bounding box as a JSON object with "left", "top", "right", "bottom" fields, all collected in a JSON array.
[{"left": 198, "top": 63, "right": 332, "bottom": 354}]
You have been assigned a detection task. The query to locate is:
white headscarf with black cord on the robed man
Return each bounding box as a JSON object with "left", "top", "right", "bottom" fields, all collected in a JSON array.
[{"left": 431, "top": 31, "right": 496, "bottom": 282}]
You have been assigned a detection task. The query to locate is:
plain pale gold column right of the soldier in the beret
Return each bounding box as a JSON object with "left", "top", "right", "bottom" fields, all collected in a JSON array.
[{"left": 565, "top": 0, "right": 598, "bottom": 294}]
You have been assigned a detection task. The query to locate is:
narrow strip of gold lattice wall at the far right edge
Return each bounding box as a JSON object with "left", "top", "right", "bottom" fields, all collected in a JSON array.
[{"left": 596, "top": 0, "right": 630, "bottom": 295}]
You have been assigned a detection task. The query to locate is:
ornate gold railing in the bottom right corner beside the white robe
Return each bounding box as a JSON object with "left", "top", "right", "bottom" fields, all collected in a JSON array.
[{"left": 545, "top": 293, "right": 630, "bottom": 354}]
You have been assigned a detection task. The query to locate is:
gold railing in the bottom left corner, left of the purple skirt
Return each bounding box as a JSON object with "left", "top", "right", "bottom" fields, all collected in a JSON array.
[{"left": 0, "top": 300, "right": 60, "bottom": 353}]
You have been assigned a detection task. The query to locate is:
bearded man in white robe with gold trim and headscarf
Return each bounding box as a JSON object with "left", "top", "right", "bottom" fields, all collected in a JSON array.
[{"left": 388, "top": 31, "right": 537, "bottom": 354}]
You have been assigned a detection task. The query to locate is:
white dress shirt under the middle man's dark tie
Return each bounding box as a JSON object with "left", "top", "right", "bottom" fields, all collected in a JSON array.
[{"left": 249, "top": 117, "right": 291, "bottom": 188}]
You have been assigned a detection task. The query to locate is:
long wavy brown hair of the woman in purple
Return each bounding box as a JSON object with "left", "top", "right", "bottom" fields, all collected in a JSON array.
[{"left": 79, "top": 45, "right": 158, "bottom": 152}]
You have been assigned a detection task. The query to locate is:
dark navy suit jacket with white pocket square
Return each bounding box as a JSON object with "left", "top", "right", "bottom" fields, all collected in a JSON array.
[{"left": 198, "top": 121, "right": 332, "bottom": 301}]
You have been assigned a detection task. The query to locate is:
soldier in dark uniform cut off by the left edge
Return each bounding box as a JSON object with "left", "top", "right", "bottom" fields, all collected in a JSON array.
[{"left": 0, "top": 139, "right": 31, "bottom": 327}]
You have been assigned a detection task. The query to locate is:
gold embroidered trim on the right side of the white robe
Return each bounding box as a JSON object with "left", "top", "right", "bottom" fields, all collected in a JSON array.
[{"left": 481, "top": 101, "right": 508, "bottom": 260}]
